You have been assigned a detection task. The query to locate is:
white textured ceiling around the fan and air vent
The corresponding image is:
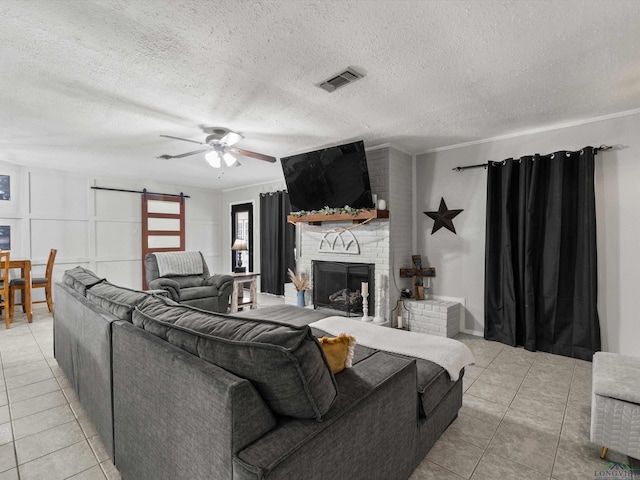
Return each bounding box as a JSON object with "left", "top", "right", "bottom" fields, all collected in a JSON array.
[{"left": 0, "top": 0, "right": 640, "bottom": 188}]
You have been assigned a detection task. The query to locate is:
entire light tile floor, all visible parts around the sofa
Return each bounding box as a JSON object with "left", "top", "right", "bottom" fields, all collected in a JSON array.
[{"left": 0, "top": 296, "right": 627, "bottom": 480}]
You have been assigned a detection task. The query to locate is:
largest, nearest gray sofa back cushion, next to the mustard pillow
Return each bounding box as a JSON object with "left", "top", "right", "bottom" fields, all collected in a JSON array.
[{"left": 133, "top": 297, "right": 337, "bottom": 421}]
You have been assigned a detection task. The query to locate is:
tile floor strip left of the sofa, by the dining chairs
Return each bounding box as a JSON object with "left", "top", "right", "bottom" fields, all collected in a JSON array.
[{"left": 0, "top": 305, "right": 120, "bottom": 480}]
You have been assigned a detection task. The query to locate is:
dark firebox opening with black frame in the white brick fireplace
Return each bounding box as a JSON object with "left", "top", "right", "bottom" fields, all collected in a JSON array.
[{"left": 313, "top": 260, "right": 375, "bottom": 317}]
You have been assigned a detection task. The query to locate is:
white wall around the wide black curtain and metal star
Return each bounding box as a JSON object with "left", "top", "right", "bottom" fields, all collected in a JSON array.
[{"left": 416, "top": 110, "right": 640, "bottom": 355}]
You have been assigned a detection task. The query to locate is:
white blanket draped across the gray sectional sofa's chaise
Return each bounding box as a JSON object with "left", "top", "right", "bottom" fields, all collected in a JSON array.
[{"left": 309, "top": 317, "right": 475, "bottom": 381}]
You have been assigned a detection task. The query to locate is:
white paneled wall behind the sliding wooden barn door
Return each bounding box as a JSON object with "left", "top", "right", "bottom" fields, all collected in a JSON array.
[{"left": 0, "top": 163, "right": 222, "bottom": 299}]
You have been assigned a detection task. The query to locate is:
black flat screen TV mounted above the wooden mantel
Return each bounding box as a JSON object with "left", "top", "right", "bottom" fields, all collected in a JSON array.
[{"left": 280, "top": 141, "right": 373, "bottom": 211}]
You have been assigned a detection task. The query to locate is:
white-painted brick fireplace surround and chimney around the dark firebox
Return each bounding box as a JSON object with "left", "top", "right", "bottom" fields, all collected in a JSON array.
[{"left": 285, "top": 145, "right": 415, "bottom": 326}]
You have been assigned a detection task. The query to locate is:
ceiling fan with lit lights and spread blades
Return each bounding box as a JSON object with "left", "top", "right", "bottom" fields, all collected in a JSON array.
[{"left": 156, "top": 127, "right": 276, "bottom": 168}]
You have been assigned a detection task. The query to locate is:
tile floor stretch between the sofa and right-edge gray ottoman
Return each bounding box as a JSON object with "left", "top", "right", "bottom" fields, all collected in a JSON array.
[{"left": 410, "top": 334, "right": 628, "bottom": 480}]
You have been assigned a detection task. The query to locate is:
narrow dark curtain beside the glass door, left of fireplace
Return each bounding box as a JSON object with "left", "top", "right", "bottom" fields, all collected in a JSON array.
[{"left": 260, "top": 192, "right": 295, "bottom": 295}]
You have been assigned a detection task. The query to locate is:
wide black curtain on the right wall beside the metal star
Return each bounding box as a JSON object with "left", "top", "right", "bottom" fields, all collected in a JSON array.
[{"left": 484, "top": 147, "right": 600, "bottom": 360}]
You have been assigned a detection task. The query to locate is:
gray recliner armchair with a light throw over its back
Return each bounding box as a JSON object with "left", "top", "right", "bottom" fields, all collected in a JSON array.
[{"left": 144, "top": 252, "right": 233, "bottom": 313}]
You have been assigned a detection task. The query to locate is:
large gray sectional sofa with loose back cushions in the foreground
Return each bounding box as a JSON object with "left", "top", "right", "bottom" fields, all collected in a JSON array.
[{"left": 54, "top": 267, "right": 462, "bottom": 480}]
